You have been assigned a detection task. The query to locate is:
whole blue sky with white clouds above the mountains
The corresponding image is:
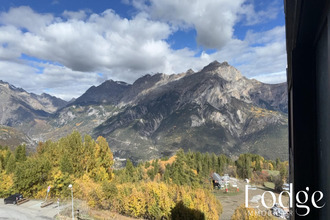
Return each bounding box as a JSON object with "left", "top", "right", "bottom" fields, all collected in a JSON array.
[{"left": 0, "top": 0, "right": 286, "bottom": 100}]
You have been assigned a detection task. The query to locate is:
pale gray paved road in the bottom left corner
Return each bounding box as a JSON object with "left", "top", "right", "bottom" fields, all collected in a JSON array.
[{"left": 0, "top": 199, "right": 62, "bottom": 220}]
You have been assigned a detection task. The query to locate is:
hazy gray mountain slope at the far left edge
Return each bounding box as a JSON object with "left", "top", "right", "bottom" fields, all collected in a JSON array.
[{"left": 0, "top": 80, "right": 67, "bottom": 149}]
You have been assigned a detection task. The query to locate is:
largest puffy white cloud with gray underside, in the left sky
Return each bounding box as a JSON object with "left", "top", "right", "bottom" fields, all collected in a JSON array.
[{"left": 0, "top": 7, "right": 171, "bottom": 75}]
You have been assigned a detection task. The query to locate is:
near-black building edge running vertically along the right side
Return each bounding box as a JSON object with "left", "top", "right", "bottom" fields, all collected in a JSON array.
[{"left": 284, "top": 0, "right": 330, "bottom": 219}]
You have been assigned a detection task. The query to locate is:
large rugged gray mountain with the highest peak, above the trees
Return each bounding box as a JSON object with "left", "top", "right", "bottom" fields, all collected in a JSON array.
[{"left": 94, "top": 61, "right": 287, "bottom": 160}]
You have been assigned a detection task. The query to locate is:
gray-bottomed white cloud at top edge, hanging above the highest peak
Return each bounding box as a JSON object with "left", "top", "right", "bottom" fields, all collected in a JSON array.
[{"left": 126, "top": 0, "right": 244, "bottom": 49}]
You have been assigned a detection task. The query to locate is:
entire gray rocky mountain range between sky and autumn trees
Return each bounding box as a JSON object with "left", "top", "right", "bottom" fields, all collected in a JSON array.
[{"left": 0, "top": 61, "right": 288, "bottom": 162}]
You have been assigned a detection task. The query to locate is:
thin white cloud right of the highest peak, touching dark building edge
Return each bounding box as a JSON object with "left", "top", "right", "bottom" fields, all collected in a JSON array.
[{"left": 206, "top": 26, "right": 286, "bottom": 80}]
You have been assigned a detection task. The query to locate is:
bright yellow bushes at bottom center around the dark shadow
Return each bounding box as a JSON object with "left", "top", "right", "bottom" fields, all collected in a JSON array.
[{"left": 112, "top": 182, "right": 222, "bottom": 219}]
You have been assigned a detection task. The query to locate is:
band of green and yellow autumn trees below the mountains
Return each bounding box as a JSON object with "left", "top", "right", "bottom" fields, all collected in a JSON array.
[{"left": 0, "top": 132, "right": 287, "bottom": 219}]
